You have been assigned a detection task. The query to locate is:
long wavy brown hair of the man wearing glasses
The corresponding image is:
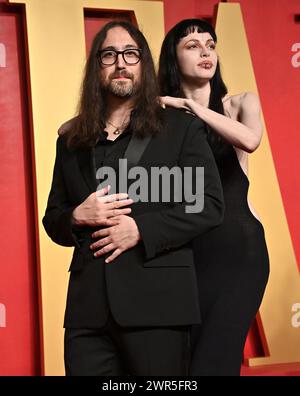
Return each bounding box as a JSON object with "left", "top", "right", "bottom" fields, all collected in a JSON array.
[{"left": 66, "top": 21, "right": 162, "bottom": 147}]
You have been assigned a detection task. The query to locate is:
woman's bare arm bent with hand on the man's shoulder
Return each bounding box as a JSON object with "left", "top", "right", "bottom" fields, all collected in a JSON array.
[{"left": 161, "top": 92, "right": 262, "bottom": 153}]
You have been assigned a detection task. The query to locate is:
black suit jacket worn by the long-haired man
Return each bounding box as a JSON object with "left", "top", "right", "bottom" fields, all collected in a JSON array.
[{"left": 43, "top": 109, "right": 223, "bottom": 328}]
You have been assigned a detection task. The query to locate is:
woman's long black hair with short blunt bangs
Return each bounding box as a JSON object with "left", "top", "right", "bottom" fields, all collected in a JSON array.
[{"left": 158, "top": 19, "right": 228, "bottom": 149}]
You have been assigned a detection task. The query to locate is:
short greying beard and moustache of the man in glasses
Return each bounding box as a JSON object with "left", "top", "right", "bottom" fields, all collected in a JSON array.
[{"left": 102, "top": 72, "right": 140, "bottom": 98}]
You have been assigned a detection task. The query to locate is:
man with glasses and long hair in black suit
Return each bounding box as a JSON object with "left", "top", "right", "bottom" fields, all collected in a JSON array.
[{"left": 43, "top": 21, "right": 223, "bottom": 375}]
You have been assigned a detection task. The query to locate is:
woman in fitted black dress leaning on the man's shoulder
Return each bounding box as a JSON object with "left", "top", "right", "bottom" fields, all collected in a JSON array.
[{"left": 159, "top": 19, "right": 269, "bottom": 375}]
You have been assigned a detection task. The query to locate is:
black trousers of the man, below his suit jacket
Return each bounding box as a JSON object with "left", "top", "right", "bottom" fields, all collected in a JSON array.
[{"left": 65, "top": 314, "right": 190, "bottom": 376}]
